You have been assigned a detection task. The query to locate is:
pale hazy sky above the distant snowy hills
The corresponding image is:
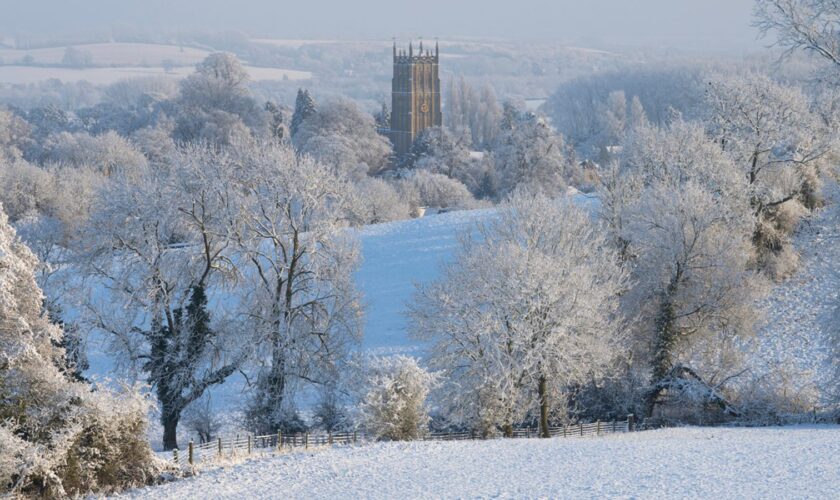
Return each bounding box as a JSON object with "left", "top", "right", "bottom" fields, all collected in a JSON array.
[{"left": 0, "top": 0, "right": 764, "bottom": 50}]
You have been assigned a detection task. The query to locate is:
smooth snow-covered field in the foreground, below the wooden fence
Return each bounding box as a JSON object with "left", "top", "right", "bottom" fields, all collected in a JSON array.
[{"left": 118, "top": 426, "right": 840, "bottom": 499}]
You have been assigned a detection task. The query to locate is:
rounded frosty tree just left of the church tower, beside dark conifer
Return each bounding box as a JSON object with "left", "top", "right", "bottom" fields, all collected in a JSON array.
[{"left": 292, "top": 98, "right": 392, "bottom": 179}]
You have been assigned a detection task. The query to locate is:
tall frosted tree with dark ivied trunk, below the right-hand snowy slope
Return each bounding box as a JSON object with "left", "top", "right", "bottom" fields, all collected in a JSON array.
[{"left": 600, "top": 119, "right": 757, "bottom": 415}]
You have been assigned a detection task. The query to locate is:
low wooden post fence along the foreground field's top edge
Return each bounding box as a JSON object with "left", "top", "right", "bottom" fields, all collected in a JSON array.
[{"left": 173, "top": 415, "right": 636, "bottom": 465}]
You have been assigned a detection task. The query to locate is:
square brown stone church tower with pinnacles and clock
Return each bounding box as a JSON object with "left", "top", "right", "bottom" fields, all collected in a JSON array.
[{"left": 391, "top": 41, "right": 443, "bottom": 158}]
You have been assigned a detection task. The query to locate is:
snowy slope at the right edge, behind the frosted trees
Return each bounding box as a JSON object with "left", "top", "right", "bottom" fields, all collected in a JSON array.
[{"left": 758, "top": 192, "right": 840, "bottom": 398}]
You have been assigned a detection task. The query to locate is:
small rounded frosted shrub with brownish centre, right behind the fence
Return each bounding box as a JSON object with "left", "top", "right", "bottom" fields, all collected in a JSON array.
[{"left": 359, "top": 356, "right": 437, "bottom": 441}]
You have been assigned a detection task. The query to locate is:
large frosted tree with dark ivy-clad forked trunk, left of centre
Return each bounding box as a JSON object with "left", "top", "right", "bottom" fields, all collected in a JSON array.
[{"left": 80, "top": 147, "right": 242, "bottom": 450}]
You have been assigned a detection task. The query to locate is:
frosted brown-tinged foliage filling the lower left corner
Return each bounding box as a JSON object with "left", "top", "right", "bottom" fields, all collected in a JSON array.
[{"left": 0, "top": 202, "right": 159, "bottom": 498}]
